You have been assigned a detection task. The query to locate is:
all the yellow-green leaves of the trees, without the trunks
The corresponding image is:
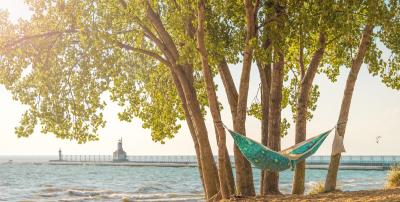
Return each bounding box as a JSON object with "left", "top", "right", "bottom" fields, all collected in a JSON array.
[{"left": 0, "top": 0, "right": 400, "bottom": 143}]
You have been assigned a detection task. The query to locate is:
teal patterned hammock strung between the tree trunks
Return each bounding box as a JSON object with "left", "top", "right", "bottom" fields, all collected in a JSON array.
[{"left": 225, "top": 127, "right": 333, "bottom": 172}]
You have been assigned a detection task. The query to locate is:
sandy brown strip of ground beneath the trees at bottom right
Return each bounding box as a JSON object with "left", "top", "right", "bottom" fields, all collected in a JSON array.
[{"left": 227, "top": 188, "right": 400, "bottom": 202}]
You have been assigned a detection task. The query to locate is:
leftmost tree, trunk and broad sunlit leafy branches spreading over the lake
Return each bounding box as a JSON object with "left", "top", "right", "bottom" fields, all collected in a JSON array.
[{"left": 1, "top": 1, "right": 223, "bottom": 198}]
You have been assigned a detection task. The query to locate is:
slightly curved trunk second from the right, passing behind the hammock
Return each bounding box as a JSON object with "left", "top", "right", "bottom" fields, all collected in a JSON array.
[{"left": 292, "top": 32, "right": 326, "bottom": 194}]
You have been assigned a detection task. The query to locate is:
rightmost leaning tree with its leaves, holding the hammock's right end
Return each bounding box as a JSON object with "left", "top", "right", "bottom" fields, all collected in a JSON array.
[{"left": 325, "top": 0, "right": 400, "bottom": 192}]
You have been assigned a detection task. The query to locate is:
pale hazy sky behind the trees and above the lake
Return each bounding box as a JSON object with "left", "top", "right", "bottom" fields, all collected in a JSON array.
[{"left": 0, "top": 0, "right": 400, "bottom": 155}]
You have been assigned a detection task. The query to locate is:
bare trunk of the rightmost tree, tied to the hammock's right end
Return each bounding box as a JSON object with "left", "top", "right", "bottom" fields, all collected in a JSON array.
[{"left": 325, "top": 24, "right": 374, "bottom": 192}]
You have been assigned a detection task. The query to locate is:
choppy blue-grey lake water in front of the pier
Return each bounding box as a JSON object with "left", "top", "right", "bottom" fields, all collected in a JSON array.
[{"left": 0, "top": 156, "right": 387, "bottom": 201}]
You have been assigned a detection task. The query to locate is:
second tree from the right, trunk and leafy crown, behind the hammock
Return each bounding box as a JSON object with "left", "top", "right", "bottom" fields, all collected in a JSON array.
[{"left": 289, "top": 1, "right": 351, "bottom": 194}]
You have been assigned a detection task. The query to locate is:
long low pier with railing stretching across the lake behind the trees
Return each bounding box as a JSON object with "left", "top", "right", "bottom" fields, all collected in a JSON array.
[{"left": 49, "top": 155, "right": 400, "bottom": 170}]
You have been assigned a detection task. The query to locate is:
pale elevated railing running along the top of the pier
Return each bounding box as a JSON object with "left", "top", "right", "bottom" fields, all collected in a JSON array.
[{"left": 62, "top": 155, "right": 400, "bottom": 166}]
